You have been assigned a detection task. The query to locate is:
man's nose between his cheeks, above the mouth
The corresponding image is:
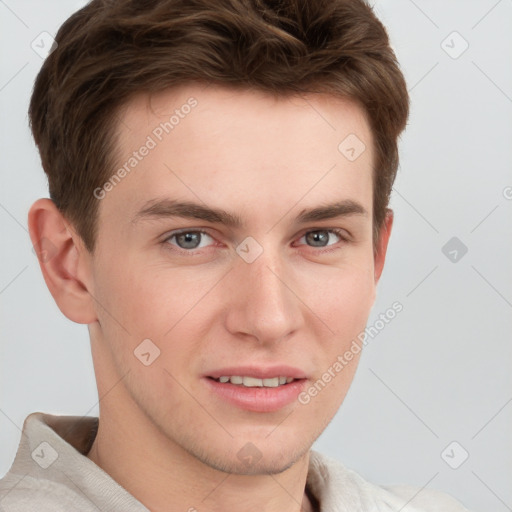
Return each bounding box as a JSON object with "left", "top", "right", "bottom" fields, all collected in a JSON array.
[{"left": 226, "top": 245, "right": 304, "bottom": 344}]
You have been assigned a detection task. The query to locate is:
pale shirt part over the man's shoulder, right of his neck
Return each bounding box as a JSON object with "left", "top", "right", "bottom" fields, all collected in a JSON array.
[{"left": 308, "top": 451, "right": 468, "bottom": 512}]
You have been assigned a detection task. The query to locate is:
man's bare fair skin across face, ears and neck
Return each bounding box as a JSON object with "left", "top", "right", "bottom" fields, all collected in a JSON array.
[{"left": 29, "top": 85, "right": 393, "bottom": 512}]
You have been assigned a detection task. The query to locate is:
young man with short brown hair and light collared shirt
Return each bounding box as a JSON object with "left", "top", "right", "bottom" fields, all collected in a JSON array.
[{"left": 0, "top": 0, "right": 470, "bottom": 512}]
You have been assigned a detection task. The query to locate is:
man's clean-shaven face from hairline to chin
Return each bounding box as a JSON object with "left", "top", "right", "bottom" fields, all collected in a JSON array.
[{"left": 89, "top": 86, "right": 384, "bottom": 474}]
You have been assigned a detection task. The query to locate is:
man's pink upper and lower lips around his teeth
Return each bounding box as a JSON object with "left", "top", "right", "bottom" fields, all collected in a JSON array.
[{"left": 202, "top": 365, "right": 307, "bottom": 413}]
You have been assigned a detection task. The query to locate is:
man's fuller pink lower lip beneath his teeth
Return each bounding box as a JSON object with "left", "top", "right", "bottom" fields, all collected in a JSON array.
[{"left": 204, "top": 377, "right": 306, "bottom": 412}]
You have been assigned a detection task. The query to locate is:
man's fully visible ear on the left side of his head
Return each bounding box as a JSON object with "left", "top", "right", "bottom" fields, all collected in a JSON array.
[{"left": 28, "top": 198, "right": 97, "bottom": 324}]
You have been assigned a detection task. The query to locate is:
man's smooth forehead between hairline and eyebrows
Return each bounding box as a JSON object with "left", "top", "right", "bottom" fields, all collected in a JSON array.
[{"left": 100, "top": 85, "right": 373, "bottom": 228}]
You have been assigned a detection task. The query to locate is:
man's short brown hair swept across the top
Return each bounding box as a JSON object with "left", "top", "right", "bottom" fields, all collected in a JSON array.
[{"left": 29, "top": 0, "right": 409, "bottom": 252}]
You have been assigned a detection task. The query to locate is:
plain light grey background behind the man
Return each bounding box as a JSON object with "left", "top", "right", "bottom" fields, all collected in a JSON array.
[{"left": 0, "top": 0, "right": 512, "bottom": 512}]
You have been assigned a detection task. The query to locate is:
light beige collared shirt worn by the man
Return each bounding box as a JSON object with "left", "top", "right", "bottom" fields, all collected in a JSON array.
[{"left": 0, "top": 412, "right": 467, "bottom": 512}]
